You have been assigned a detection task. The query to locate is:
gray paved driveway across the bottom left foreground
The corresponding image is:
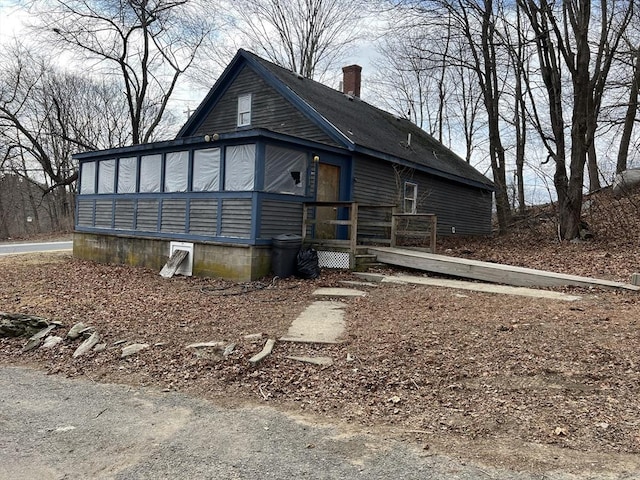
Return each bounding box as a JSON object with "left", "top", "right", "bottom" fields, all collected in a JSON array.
[{"left": 0, "top": 367, "right": 564, "bottom": 480}]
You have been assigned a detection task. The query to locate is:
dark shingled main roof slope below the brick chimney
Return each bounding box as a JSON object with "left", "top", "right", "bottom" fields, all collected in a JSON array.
[{"left": 239, "top": 50, "right": 493, "bottom": 187}]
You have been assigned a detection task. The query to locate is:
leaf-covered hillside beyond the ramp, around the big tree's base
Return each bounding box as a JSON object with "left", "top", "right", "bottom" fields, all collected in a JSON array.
[{"left": 438, "top": 190, "right": 640, "bottom": 282}]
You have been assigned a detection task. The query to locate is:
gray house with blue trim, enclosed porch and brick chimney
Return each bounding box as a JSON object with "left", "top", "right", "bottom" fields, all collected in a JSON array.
[{"left": 74, "top": 50, "right": 493, "bottom": 281}]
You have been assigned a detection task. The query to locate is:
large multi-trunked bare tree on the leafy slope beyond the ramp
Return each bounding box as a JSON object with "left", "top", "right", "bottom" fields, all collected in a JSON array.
[{"left": 518, "top": 0, "right": 633, "bottom": 239}]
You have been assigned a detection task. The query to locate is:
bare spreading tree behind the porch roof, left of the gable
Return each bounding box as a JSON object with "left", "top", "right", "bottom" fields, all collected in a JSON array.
[{"left": 36, "top": 0, "right": 212, "bottom": 144}]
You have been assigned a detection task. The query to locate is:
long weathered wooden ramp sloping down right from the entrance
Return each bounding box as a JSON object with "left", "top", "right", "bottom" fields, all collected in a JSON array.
[{"left": 368, "top": 247, "right": 640, "bottom": 291}]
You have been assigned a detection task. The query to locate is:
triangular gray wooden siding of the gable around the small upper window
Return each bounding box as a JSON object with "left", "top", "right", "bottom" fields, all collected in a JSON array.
[{"left": 194, "top": 66, "right": 337, "bottom": 145}]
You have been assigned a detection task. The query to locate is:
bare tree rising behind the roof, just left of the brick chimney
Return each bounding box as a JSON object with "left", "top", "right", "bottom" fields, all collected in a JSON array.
[{"left": 229, "top": 0, "right": 369, "bottom": 78}]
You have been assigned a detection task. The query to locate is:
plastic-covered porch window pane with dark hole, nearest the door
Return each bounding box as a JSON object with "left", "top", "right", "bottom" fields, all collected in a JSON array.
[{"left": 264, "top": 145, "right": 307, "bottom": 195}]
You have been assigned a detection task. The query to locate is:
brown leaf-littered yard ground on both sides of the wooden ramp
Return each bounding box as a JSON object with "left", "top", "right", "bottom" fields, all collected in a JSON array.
[{"left": 0, "top": 231, "right": 640, "bottom": 478}]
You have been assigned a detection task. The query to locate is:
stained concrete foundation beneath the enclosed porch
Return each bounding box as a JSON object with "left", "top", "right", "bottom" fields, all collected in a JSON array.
[{"left": 73, "top": 232, "right": 271, "bottom": 282}]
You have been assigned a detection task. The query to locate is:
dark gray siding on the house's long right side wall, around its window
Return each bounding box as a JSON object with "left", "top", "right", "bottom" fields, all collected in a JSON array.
[{"left": 353, "top": 157, "right": 492, "bottom": 235}]
